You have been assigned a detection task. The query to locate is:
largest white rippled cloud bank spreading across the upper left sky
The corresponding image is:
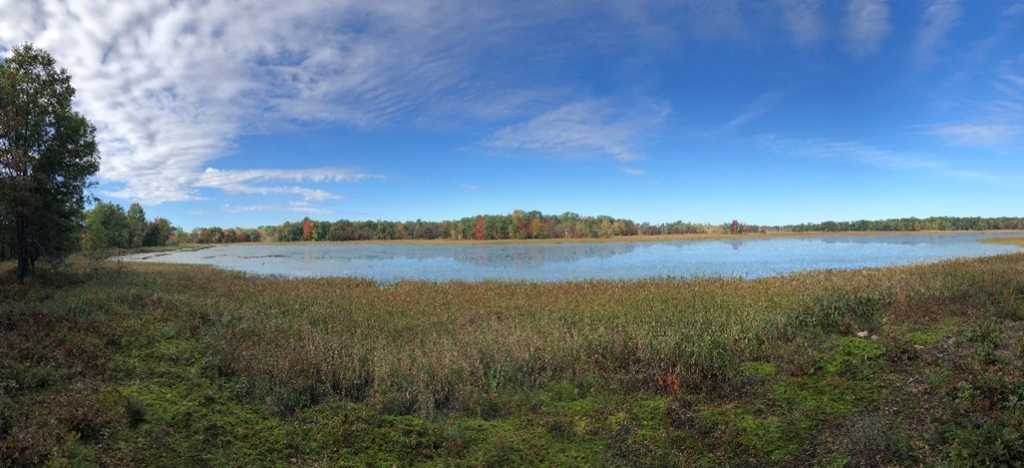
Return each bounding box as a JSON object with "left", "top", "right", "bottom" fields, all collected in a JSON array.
[{"left": 0, "top": 0, "right": 528, "bottom": 204}]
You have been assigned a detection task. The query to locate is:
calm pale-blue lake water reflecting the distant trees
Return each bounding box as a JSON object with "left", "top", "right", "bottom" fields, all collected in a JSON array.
[{"left": 121, "top": 233, "right": 1020, "bottom": 282}]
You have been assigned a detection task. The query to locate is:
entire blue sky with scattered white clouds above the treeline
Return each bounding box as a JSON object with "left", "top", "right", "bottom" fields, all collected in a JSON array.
[{"left": 0, "top": 0, "right": 1024, "bottom": 229}]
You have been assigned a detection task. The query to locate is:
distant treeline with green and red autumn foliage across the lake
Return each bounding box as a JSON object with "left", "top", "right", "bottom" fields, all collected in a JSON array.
[{"left": 175, "top": 210, "right": 1024, "bottom": 244}]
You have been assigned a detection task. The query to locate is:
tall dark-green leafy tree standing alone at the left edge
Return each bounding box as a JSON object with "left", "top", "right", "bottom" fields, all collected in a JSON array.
[{"left": 0, "top": 44, "right": 99, "bottom": 284}]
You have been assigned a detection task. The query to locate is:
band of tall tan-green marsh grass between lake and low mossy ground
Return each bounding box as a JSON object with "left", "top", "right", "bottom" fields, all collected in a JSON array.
[{"left": 105, "top": 254, "right": 1024, "bottom": 414}]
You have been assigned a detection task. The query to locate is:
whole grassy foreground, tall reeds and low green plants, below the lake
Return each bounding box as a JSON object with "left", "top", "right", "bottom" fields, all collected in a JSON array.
[{"left": 0, "top": 254, "right": 1024, "bottom": 466}]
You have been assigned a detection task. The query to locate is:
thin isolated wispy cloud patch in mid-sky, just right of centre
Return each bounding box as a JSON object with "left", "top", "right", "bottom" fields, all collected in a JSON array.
[{"left": 484, "top": 99, "right": 666, "bottom": 161}]
